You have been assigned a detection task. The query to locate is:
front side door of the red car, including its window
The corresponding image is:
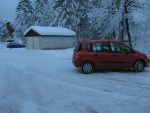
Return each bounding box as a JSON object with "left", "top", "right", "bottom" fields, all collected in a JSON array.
[{"left": 110, "top": 42, "right": 133, "bottom": 69}]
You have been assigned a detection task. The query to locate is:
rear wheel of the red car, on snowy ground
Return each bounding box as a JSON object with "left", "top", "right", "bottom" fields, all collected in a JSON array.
[{"left": 81, "top": 62, "right": 94, "bottom": 74}]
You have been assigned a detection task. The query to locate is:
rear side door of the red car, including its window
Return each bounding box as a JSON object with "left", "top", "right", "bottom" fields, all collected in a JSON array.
[{"left": 92, "top": 42, "right": 112, "bottom": 69}]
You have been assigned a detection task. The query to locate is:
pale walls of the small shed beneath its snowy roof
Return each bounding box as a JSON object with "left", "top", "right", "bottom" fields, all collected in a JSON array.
[{"left": 26, "top": 36, "right": 73, "bottom": 50}]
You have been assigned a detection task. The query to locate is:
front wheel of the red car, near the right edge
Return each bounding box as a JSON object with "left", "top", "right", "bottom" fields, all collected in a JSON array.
[{"left": 134, "top": 60, "right": 145, "bottom": 72}]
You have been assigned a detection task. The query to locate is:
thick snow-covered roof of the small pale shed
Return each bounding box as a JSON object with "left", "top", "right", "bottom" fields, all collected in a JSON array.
[{"left": 24, "top": 26, "right": 76, "bottom": 36}]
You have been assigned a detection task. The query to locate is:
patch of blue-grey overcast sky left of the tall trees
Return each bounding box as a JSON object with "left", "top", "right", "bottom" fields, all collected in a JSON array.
[{"left": 0, "top": 0, "right": 19, "bottom": 22}]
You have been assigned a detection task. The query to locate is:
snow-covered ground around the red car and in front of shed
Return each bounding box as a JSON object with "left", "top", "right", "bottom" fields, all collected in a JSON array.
[{"left": 0, "top": 45, "right": 150, "bottom": 113}]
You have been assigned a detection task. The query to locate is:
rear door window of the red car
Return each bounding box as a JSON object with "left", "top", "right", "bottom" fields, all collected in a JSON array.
[{"left": 93, "top": 42, "right": 111, "bottom": 52}]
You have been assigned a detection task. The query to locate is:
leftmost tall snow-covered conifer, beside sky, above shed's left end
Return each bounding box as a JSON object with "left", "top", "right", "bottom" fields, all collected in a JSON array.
[{"left": 15, "top": 0, "right": 34, "bottom": 38}]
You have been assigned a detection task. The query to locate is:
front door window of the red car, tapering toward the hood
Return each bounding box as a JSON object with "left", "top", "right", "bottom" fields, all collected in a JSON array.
[{"left": 110, "top": 42, "right": 130, "bottom": 53}]
